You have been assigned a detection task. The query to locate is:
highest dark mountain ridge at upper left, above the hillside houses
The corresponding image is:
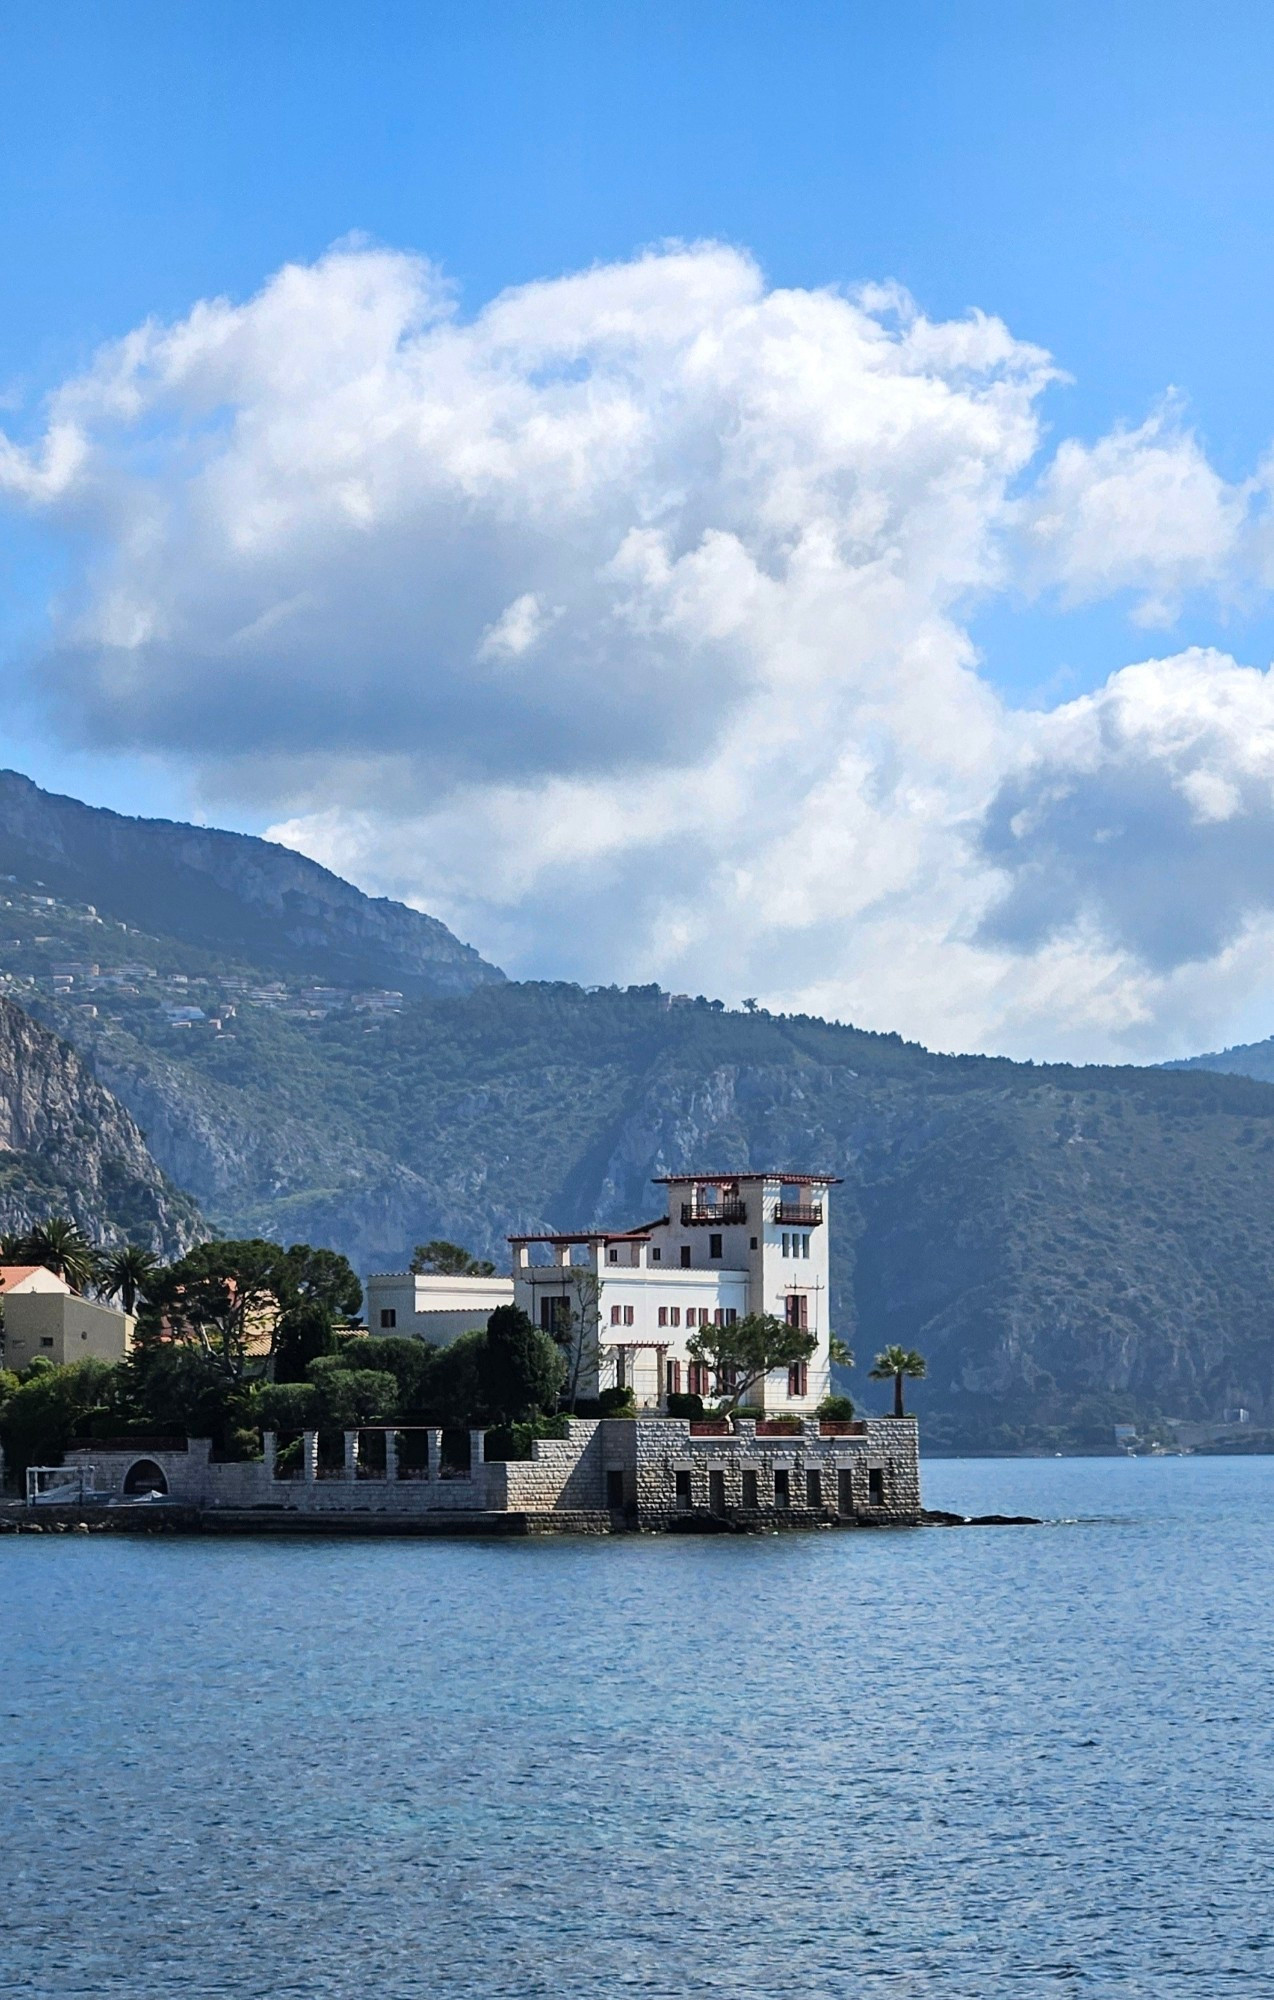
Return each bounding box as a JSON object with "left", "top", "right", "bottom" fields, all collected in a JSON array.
[{"left": 0, "top": 770, "right": 504, "bottom": 994}]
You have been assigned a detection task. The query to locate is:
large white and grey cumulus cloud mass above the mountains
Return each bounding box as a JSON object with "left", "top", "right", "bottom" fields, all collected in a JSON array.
[{"left": 0, "top": 244, "right": 1274, "bottom": 1054}]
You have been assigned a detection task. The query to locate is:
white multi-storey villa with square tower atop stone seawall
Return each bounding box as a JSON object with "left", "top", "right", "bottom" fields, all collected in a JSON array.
[{"left": 366, "top": 1174, "right": 838, "bottom": 1416}]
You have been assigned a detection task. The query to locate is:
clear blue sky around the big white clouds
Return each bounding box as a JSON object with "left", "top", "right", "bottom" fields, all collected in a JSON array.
[{"left": 0, "top": 0, "right": 1274, "bottom": 1048}]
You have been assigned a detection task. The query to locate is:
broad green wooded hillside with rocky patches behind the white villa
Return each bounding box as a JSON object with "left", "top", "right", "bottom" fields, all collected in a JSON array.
[{"left": 0, "top": 768, "right": 1274, "bottom": 1448}]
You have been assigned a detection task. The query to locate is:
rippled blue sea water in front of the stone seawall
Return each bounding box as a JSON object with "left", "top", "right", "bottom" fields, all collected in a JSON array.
[{"left": 0, "top": 1458, "right": 1274, "bottom": 2000}]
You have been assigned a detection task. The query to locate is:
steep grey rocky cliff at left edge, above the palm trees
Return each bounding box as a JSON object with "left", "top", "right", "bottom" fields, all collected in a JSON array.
[{"left": 0, "top": 1000, "right": 200, "bottom": 1256}]
